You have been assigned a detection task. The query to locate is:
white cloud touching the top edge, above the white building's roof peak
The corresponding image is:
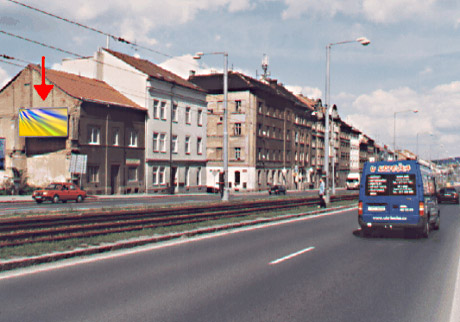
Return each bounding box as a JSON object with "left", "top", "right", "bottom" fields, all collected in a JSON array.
[{"left": 23, "top": 0, "right": 255, "bottom": 49}]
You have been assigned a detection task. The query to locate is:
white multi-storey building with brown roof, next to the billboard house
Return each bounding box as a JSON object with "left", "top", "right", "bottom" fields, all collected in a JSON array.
[{"left": 63, "top": 49, "right": 207, "bottom": 193}]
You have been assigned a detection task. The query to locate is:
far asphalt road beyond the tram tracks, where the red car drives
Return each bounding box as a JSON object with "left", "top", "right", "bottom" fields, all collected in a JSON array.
[{"left": 0, "top": 190, "right": 356, "bottom": 216}]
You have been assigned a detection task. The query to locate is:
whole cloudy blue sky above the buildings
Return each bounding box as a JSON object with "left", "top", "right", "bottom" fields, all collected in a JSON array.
[{"left": 0, "top": 0, "right": 460, "bottom": 159}]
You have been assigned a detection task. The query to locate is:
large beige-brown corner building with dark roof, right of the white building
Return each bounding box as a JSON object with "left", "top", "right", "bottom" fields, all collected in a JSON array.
[{"left": 189, "top": 72, "right": 314, "bottom": 191}]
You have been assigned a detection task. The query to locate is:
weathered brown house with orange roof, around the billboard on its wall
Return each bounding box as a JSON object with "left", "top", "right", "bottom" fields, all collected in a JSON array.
[{"left": 0, "top": 65, "right": 146, "bottom": 194}]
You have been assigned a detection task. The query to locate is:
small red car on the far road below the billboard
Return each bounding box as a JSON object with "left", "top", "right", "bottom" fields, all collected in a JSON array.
[{"left": 32, "top": 182, "right": 86, "bottom": 203}]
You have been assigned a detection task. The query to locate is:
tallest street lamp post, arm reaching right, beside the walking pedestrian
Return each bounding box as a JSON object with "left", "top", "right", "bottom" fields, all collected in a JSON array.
[{"left": 323, "top": 37, "right": 371, "bottom": 204}]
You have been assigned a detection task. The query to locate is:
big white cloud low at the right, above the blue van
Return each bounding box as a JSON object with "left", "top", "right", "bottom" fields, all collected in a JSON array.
[{"left": 339, "top": 81, "right": 460, "bottom": 157}]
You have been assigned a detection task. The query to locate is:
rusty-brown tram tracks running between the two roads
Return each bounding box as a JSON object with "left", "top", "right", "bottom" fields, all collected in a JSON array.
[{"left": 0, "top": 195, "right": 357, "bottom": 247}]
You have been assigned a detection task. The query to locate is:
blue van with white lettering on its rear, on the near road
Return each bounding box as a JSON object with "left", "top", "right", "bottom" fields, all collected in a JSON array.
[{"left": 358, "top": 160, "right": 440, "bottom": 238}]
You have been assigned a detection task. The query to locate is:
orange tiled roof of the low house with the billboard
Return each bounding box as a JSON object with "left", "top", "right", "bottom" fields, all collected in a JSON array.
[{"left": 27, "top": 65, "right": 146, "bottom": 111}]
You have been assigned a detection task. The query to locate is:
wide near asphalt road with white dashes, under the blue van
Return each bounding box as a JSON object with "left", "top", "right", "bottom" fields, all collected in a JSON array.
[{"left": 0, "top": 205, "right": 460, "bottom": 322}]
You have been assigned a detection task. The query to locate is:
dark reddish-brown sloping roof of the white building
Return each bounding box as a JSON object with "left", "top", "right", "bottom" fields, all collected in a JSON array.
[{"left": 104, "top": 48, "right": 204, "bottom": 92}]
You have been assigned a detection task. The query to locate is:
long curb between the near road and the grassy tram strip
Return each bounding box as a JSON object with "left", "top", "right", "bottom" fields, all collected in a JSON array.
[{"left": 0, "top": 205, "right": 356, "bottom": 272}]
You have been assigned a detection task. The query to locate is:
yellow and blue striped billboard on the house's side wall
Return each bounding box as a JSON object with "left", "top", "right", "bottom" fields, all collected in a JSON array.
[{"left": 19, "top": 107, "right": 68, "bottom": 137}]
